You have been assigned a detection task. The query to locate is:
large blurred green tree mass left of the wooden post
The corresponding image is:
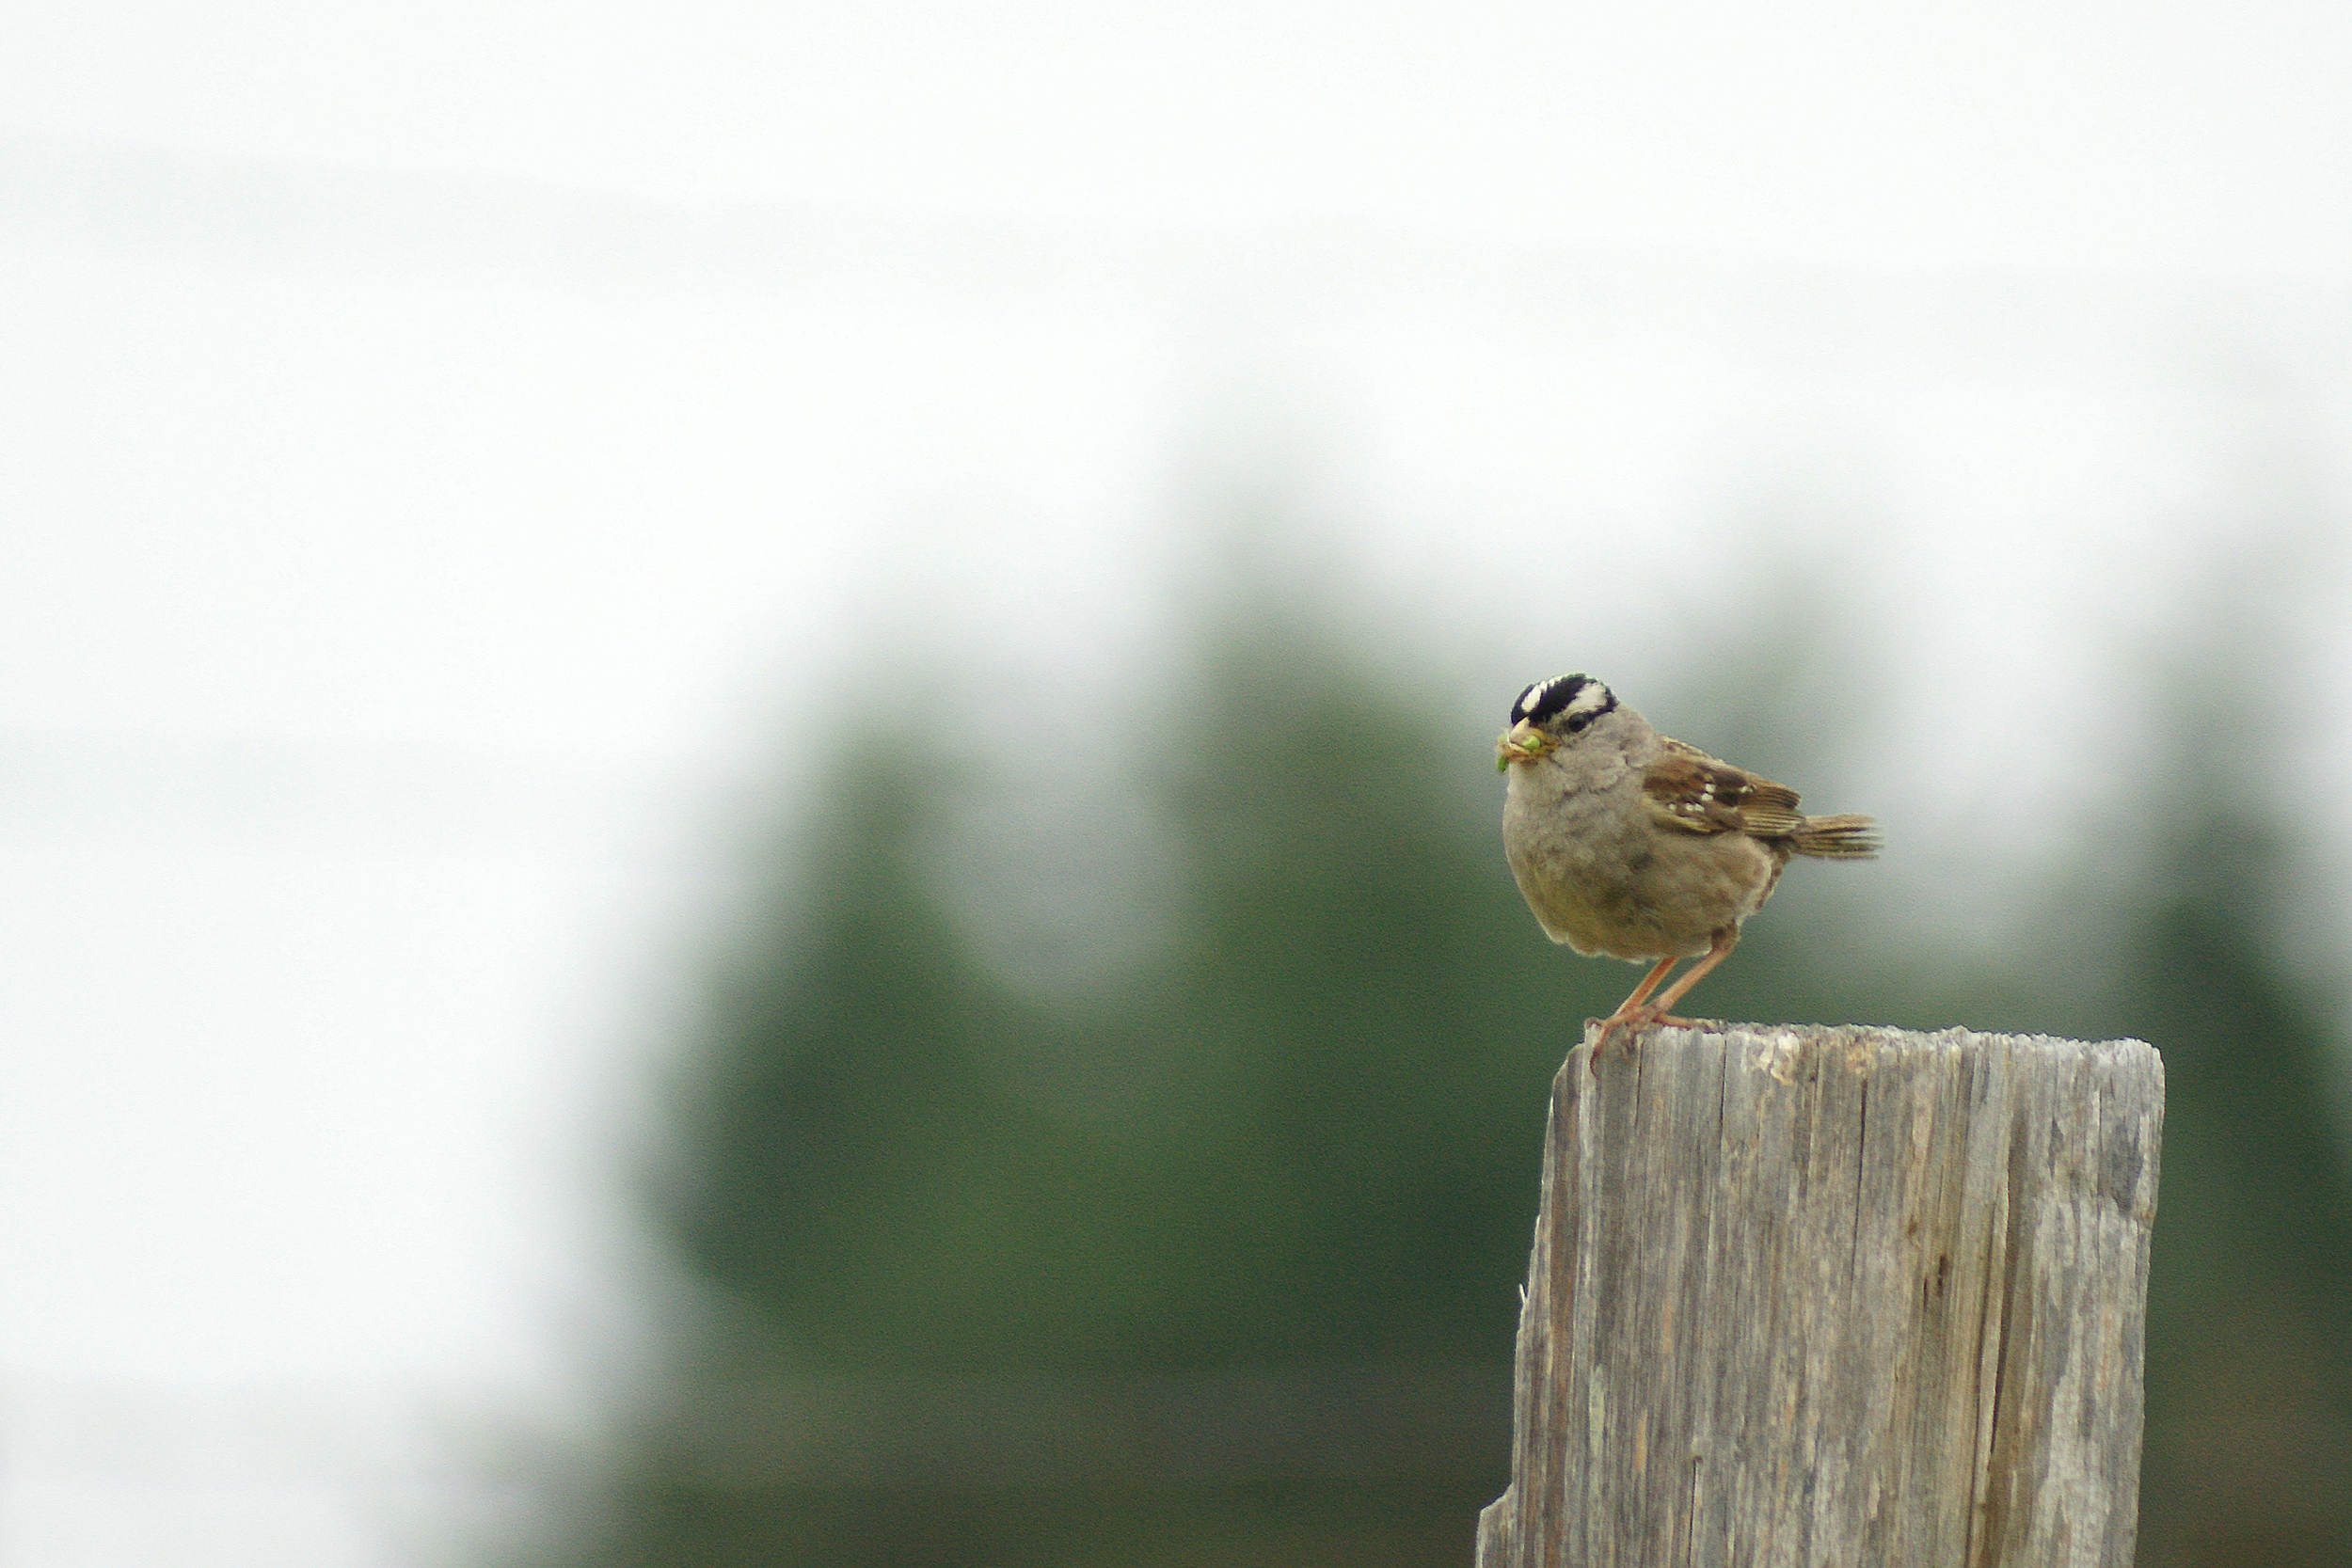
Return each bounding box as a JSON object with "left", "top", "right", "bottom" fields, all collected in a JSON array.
[{"left": 533, "top": 618, "right": 1630, "bottom": 1568}]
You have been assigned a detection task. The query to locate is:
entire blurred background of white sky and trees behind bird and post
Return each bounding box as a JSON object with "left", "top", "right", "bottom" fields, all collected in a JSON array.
[{"left": 0, "top": 5, "right": 2352, "bottom": 1568}]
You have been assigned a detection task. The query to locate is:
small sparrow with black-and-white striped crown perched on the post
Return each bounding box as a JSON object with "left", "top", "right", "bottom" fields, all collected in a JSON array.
[{"left": 1494, "top": 674, "right": 1880, "bottom": 1072}]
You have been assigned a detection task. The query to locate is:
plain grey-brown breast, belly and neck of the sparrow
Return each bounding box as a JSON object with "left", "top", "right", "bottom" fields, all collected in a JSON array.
[{"left": 1503, "top": 703, "right": 1792, "bottom": 964}]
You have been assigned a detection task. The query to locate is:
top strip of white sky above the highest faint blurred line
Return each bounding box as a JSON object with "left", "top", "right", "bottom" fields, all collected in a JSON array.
[{"left": 13, "top": 0, "right": 2352, "bottom": 268}]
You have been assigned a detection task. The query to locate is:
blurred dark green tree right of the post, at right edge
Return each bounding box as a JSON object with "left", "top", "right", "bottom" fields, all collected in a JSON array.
[{"left": 2084, "top": 770, "right": 2352, "bottom": 1568}]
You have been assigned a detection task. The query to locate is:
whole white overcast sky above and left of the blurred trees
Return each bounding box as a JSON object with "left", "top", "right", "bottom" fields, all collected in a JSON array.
[{"left": 0, "top": 2, "right": 2352, "bottom": 1568}]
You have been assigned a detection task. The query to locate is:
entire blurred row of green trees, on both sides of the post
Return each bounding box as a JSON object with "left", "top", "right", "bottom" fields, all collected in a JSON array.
[{"left": 519, "top": 616, "right": 2352, "bottom": 1568}]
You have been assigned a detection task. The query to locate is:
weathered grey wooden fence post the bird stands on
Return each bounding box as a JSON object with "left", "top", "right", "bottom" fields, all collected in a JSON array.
[{"left": 1477, "top": 1025, "right": 2164, "bottom": 1568}]
